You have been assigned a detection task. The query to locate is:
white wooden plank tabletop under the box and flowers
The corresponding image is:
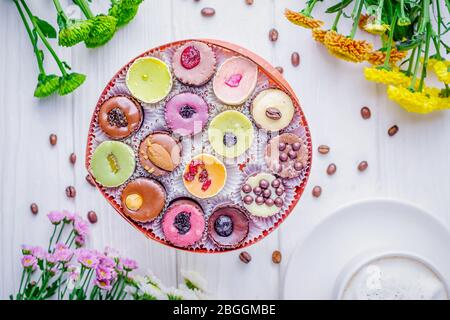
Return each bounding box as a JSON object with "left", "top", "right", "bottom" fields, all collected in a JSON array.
[{"left": 0, "top": 0, "right": 450, "bottom": 299}]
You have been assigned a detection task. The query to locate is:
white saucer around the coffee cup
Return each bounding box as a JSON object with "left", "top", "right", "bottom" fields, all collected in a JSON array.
[{"left": 283, "top": 199, "right": 450, "bottom": 299}]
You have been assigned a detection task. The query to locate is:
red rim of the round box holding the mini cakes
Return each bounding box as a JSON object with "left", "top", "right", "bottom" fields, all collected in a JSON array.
[{"left": 85, "top": 39, "right": 312, "bottom": 253}]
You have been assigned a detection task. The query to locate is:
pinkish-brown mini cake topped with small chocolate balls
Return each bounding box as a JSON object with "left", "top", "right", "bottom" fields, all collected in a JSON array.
[{"left": 265, "top": 133, "right": 308, "bottom": 178}]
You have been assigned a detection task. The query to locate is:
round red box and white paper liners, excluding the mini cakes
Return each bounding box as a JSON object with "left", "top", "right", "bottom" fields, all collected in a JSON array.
[{"left": 86, "top": 40, "right": 312, "bottom": 253}]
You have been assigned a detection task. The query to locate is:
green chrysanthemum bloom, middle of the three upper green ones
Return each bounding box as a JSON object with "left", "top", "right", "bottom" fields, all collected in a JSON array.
[{"left": 84, "top": 15, "right": 117, "bottom": 48}]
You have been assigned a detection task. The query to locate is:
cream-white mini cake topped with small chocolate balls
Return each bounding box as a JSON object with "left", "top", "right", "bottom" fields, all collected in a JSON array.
[{"left": 241, "top": 172, "right": 285, "bottom": 217}]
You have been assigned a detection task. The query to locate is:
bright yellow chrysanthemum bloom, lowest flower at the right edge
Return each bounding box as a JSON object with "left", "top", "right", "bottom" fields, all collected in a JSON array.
[{"left": 387, "top": 86, "right": 450, "bottom": 114}]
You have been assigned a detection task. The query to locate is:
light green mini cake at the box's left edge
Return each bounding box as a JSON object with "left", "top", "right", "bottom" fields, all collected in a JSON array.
[{"left": 90, "top": 141, "right": 136, "bottom": 187}]
